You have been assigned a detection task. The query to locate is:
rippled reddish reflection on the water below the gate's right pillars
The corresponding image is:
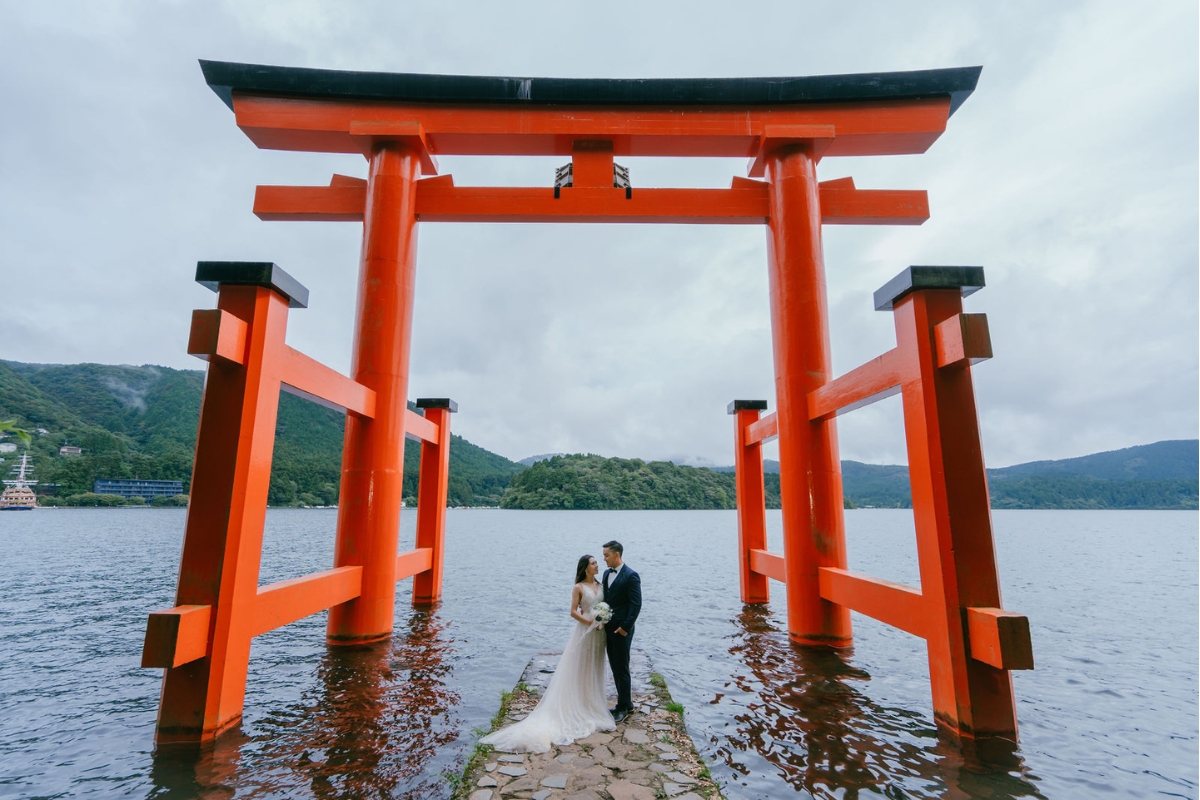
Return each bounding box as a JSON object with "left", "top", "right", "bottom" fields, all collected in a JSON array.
[{"left": 714, "top": 606, "right": 1043, "bottom": 798}]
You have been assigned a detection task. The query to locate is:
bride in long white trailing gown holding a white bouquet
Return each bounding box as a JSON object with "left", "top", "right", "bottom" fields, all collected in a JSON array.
[{"left": 480, "top": 555, "right": 617, "bottom": 753}]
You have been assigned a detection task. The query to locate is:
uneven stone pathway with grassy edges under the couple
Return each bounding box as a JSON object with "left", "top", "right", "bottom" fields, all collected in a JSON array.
[{"left": 454, "top": 650, "right": 721, "bottom": 800}]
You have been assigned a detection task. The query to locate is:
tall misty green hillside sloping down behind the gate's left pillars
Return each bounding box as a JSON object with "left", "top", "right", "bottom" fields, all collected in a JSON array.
[{"left": 0, "top": 361, "right": 523, "bottom": 505}]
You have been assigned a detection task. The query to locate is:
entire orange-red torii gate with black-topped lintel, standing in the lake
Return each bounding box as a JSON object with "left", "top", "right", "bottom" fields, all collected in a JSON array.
[{"left": 143, "top": 61, "right": 1028, "bottom": 744}]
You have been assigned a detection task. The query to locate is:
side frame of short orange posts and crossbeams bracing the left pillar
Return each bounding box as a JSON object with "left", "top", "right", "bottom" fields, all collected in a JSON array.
[{"left": 142, "top": 261, "right": 457, "bottom": 745}]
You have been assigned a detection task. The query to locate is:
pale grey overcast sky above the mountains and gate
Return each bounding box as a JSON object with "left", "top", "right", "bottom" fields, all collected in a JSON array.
[{"left": 0, "top": 0, "right": 1198, "bottom": 467}]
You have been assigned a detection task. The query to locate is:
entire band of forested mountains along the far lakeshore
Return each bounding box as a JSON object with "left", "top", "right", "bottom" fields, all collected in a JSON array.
[{"left": 0, "top": 361, "right": 1200, "bottom": 509}]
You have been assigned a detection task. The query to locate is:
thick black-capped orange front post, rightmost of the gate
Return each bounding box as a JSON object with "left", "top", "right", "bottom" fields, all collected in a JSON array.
[{"left": 875, "top": 266, "right": 1033, "bottom": 741}]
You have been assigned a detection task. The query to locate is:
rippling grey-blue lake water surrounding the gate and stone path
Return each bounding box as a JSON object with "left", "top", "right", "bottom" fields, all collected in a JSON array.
[{"left": 0, "top": 509, "right": 1198, "bottom": 799}]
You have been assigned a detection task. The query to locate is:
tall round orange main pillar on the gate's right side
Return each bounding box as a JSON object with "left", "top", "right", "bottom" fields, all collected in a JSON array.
[{"left": 768, "top": 140, "right": 851, "bottom": 646}]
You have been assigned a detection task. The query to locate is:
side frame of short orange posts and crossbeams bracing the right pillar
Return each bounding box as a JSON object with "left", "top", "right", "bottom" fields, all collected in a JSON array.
[{"left": 730, "top": 266, "right": 1033, "bottom": 741}]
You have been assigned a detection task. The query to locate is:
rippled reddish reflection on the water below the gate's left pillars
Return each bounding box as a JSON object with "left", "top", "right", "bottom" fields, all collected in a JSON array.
[{"left": 151, "top": 612, "right": 460, "bottom": 799}]
